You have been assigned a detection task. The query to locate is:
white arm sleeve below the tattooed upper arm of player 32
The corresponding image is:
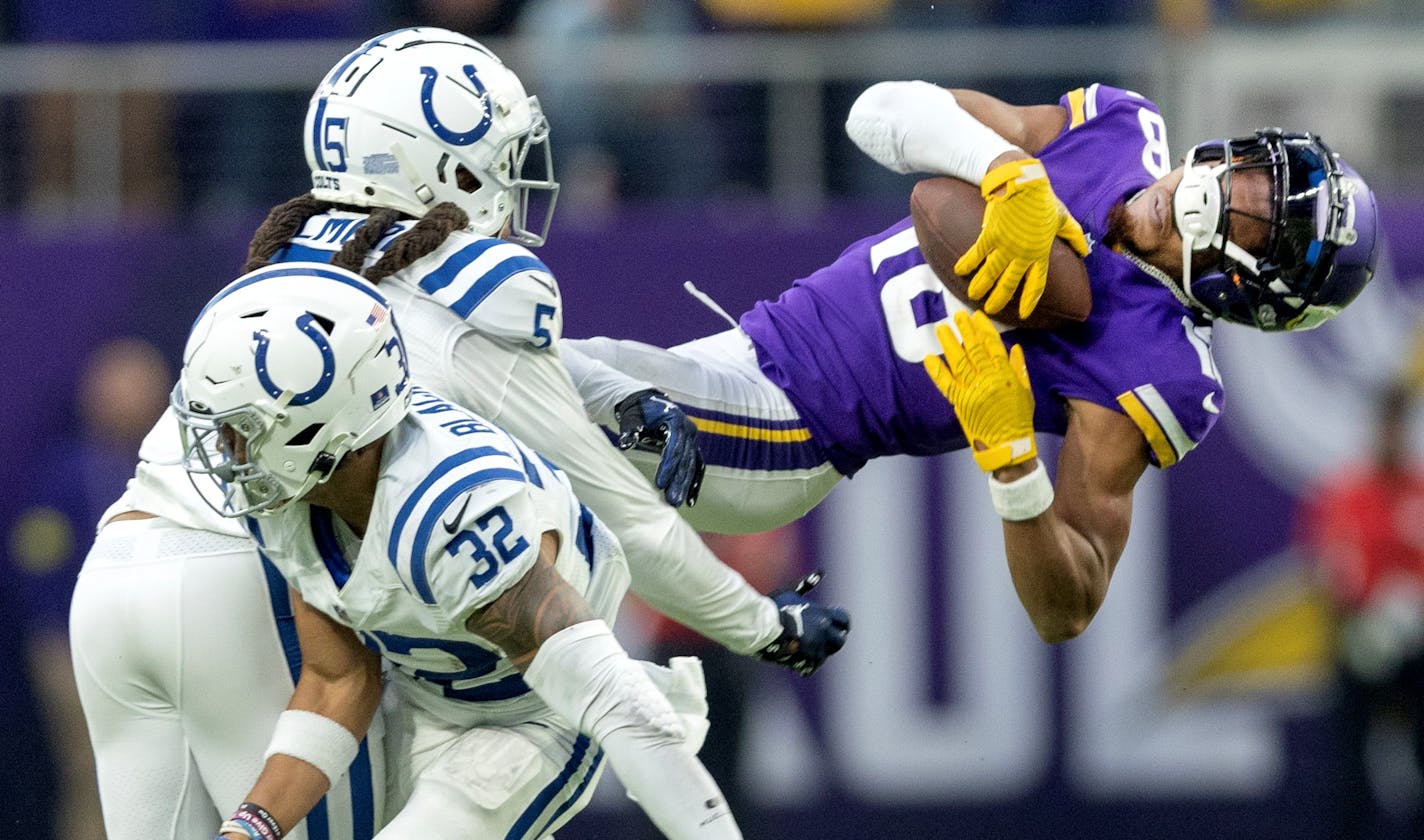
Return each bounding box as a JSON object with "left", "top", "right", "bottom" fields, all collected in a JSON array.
[{"left": 524, "top": 621, "right": 742, "bottom": 840}]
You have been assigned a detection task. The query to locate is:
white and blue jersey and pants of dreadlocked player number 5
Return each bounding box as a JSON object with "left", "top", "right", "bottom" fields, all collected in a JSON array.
[{"left": 73, "top": 211, "right": 780, "bottom": 840}]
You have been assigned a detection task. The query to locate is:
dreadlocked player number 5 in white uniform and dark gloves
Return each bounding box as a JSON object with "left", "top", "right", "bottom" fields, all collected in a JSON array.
[{"left": 71, "top": 28, "right": 849, "bottom": 840}]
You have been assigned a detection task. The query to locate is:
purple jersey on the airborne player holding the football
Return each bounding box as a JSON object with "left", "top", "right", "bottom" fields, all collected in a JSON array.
[{"left": 740, "top": 85, "right": 1222, "bottom": 476}]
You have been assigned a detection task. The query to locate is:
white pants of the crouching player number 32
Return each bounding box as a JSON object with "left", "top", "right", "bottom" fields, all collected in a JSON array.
[{"left": 377, "top": 700, "right": 604, "bottom": 840}]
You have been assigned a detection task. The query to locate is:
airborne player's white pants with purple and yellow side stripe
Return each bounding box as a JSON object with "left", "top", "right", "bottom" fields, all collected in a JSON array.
[{"left": 564, "top": 329, "right": 842, "bottom": 534}]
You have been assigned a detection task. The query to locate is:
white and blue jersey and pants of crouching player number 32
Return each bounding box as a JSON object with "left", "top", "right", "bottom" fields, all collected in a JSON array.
[{"left": 246, "top": 387, "right": 628, "bottom": 839}]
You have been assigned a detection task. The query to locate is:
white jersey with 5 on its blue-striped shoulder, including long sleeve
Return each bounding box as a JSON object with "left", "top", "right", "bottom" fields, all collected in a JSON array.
[{"left": 272, "top": 211, "right": 780, "bottom": 653}]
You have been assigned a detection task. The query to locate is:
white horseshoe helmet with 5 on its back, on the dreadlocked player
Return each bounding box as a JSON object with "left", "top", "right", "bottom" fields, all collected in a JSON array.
[{"left": 305, "top": 27, "right": 558, "bottom": 246}]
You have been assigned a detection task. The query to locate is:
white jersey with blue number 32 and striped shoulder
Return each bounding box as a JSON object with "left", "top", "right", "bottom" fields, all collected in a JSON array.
[{"left": 246, "top": 387, "right": 628, "bottom": 726}]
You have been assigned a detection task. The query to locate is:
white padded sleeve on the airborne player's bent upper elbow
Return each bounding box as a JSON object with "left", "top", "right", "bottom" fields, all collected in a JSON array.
[{"left": 846, "top": 81, "right": 1021, "bottom": 185}]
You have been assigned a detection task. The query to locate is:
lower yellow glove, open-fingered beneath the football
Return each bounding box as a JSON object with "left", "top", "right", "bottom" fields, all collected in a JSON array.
[{"left": 924, "top": 312, "right": 1038, "bottom": 473}]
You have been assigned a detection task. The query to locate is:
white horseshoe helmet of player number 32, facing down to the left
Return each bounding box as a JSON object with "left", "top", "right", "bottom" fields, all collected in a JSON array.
[{"left": 171, "top": 262, "right": 410, "bottom": 517}]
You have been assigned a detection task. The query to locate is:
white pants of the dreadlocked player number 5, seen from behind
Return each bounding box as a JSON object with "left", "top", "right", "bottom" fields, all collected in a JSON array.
[{"left": 70, "top": 518, "right": 384, "bottom": 840}]
